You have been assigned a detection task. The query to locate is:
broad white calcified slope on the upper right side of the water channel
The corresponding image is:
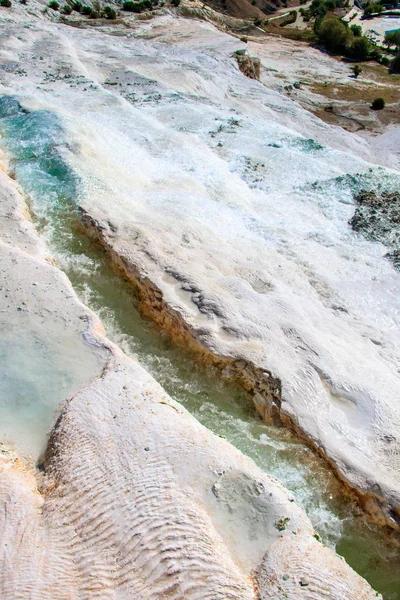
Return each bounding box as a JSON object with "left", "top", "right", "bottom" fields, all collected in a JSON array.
[{"left": 1, "top": 2, "right": 400, "bottom": 524}]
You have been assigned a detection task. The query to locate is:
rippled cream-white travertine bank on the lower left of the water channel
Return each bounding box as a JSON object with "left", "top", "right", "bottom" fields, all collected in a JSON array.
[{"left": 0, "top": 175, "right": 376, "bottom": 600}]
